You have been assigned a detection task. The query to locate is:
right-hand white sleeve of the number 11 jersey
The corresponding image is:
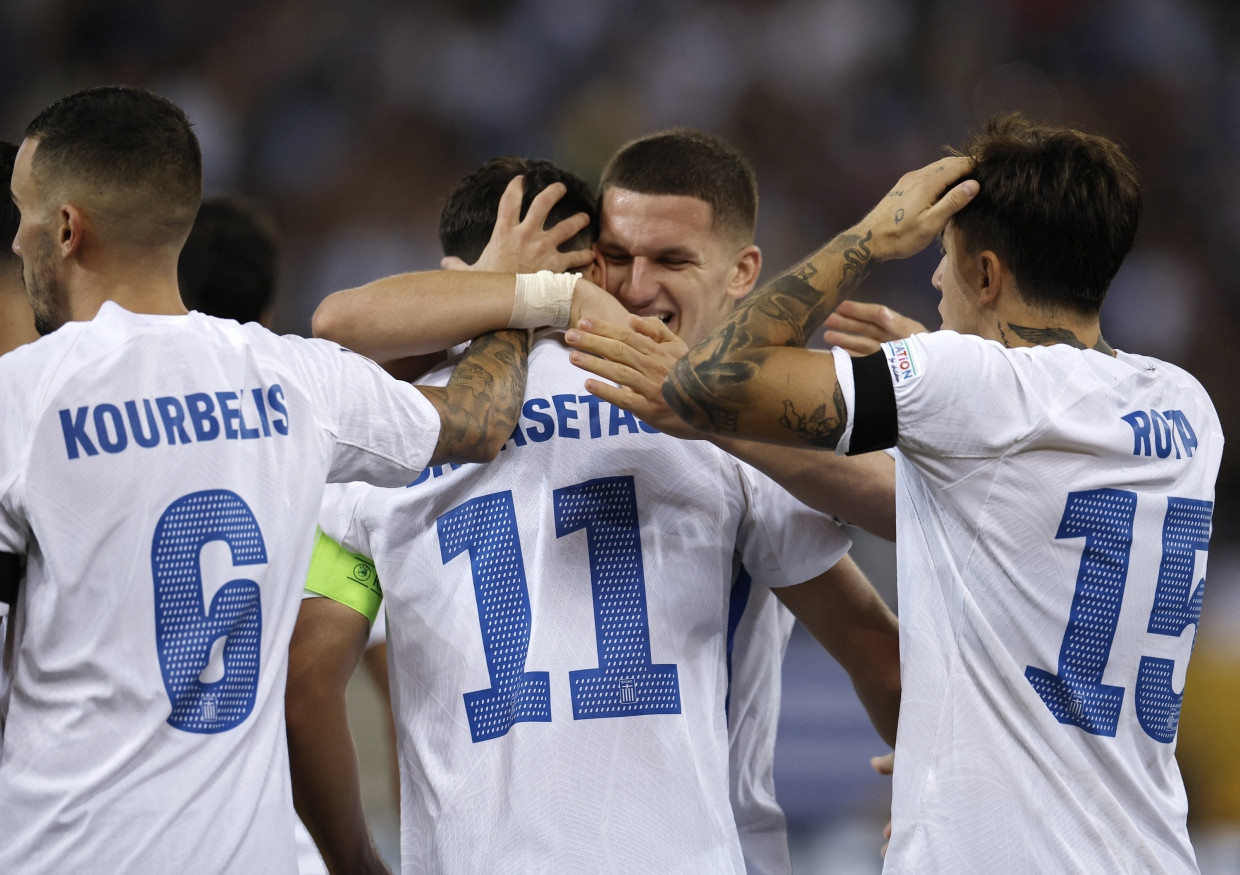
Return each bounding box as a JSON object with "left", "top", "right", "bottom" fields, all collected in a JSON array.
[{"left": 737, "top": 464, "right": 852, "bottom": 587}]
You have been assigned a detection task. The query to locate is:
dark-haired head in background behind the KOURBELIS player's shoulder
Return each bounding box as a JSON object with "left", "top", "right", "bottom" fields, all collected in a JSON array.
[{"left": 176, "top": 197, "right": 275, "bottom": 322}]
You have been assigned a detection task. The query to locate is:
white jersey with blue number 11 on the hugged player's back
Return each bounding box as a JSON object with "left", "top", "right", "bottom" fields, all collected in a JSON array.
[{"left": 320, "top": 329, "right": 848, "bottom": 874}]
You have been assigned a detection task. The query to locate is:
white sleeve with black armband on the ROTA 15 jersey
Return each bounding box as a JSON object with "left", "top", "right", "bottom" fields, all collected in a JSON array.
[{"left": 833, "top": 331, "right": 1070, "bottom": 459}]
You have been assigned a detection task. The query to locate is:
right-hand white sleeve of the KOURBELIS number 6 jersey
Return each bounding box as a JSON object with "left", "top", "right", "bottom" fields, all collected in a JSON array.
[{"left": 306, "top": 341, "right": 440, "bottom": 486}]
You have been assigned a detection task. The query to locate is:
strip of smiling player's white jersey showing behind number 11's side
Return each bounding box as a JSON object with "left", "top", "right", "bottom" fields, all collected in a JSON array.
[{"left": 728, "top": 569, "right": 796, "bottom": 875}]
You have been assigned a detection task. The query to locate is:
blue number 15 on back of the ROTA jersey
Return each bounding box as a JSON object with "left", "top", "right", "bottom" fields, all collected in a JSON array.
[{"left": 1024, "top": 490, "right": 1214, "bottom": 744}]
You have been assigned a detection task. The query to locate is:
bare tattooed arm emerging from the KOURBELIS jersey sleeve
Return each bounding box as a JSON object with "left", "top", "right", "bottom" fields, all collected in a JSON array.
[{"left": 434, "top": 330, "right": 529, "bottom": 462}]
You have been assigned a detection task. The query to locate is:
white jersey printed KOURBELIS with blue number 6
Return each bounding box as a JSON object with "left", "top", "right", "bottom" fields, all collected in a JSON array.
[{"left": 0, "top": 302, "right": 439, "bottom": 875}]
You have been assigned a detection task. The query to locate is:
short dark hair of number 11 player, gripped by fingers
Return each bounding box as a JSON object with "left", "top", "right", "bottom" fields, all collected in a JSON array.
[{"left": 439, "top": 155, "right": 599, "bottom": 264}]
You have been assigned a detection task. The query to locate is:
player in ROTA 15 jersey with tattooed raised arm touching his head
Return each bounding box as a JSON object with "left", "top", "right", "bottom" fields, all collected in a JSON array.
[{"left": 665, "top": 115, "right": 1223, "bottom": 873}]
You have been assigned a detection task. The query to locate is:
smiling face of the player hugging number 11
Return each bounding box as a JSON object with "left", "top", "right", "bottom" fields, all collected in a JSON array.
[{"left": 598, "top": 187, "right": 758, "bottom": 346}]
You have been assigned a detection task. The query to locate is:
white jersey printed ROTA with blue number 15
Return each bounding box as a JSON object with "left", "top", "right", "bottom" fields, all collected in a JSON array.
[{"left": 836, "top": 331, "right": 1223, "bottom": 875}]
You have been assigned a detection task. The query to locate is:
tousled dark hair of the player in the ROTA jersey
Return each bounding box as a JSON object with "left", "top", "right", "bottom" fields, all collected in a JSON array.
[{"left": 952, "top": 113, "right": 1141, "bottom": 314}]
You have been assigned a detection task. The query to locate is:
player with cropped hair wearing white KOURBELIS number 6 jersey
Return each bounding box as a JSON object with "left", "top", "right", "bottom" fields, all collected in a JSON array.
[{"left": 0, "top": 87, "right": 526, "bottom": 873}]
